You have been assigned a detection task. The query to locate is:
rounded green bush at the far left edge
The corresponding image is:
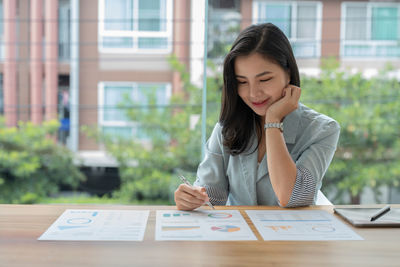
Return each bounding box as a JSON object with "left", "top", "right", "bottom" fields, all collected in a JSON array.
[{"left": 0, "top": 118, "right": 84, "bottom": 203}]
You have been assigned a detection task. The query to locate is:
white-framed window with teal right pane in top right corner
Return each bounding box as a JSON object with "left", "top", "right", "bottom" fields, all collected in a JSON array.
[{"left": 341, "top": 2, "right": 400, "bottom": 58}]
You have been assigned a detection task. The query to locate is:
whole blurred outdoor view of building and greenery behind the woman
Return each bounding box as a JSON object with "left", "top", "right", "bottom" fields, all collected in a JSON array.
[{"left": 0, "top": 0, "right": 400, "bottom": 204}]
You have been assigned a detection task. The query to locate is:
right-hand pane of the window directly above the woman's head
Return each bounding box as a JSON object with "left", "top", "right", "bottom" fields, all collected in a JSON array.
[{"left": 297, "top": 5, "right": 317, "bottom": 39}]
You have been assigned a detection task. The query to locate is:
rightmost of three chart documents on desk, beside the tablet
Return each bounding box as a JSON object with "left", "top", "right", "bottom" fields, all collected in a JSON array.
[{"left": 246, "top": 210, "right": 363, "bottom": 241}]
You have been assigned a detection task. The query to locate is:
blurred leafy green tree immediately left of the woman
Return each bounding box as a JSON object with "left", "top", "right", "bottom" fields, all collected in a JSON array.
[{"left": 85, "top": 56, "right": 222, "bottom": 203}]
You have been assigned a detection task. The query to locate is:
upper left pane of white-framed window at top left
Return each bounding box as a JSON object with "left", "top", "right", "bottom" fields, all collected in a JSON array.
[{"left": 104, "top": 0, "right": 133, "bottom": 31}]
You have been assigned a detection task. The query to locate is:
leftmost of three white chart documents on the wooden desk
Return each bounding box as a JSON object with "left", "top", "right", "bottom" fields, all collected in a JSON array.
[{"left": 38, "top": 209, "right": 149, "bottom": 241}]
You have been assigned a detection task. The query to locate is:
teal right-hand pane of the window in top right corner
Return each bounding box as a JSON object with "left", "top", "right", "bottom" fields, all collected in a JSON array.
[{"left": 371, "top": 7, "right": 399, "bottom": 40}]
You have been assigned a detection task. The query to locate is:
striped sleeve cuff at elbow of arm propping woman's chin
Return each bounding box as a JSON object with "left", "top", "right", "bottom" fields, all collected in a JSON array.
[{"left": 285, "top": 166, "right": 316, "bottom": 208}]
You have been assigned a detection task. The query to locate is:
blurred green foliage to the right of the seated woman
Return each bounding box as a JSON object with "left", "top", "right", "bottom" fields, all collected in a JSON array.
[{"left": 301, "top": 59, "right": 400, "bottom": 203}]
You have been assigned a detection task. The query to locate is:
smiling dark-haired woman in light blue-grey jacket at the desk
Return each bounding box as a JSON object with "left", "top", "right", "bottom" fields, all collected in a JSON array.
[{"left": 175, "top": 23, "right": 340, "bottom": 210}]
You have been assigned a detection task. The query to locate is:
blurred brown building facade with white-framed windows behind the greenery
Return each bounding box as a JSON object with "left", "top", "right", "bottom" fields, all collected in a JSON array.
[{"left": 0, "top": 0, "right": 400, "bottom": 157}]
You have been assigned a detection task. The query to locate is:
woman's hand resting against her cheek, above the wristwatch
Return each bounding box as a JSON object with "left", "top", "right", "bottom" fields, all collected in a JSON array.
[{"left": 265, "top": 84, "right": 301, "bottom": 122}]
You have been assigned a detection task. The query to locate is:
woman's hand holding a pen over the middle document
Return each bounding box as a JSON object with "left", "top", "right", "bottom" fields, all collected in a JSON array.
[{"left": 175, "top": 184, "right": 210, "bottom": 210}]
